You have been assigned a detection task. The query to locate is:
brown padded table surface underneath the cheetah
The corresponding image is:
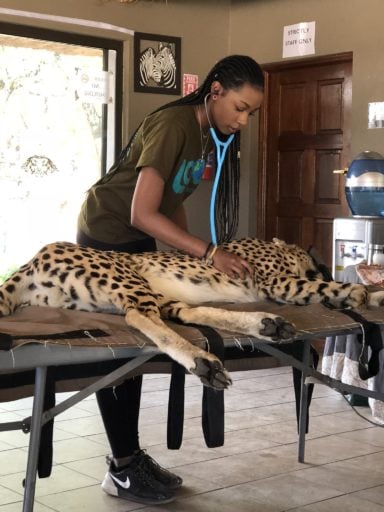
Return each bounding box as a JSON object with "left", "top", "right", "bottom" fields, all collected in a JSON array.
[{"left": 0, "top": 301, "right": 376, "bottom": 347}]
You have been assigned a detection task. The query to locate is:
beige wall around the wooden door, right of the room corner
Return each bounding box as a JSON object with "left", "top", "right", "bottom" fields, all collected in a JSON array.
[{"left": 230, "top": 0, "right": 384, "bottom": 234}]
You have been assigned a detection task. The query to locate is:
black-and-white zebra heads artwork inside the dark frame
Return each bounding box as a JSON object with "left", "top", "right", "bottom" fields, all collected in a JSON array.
[{"left": 139, "top": 43, "right": 176, "bottom": 89}]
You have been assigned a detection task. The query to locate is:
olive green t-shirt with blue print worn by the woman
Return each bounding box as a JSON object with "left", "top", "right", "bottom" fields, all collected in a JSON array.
[{"left": 78, "top": 105, "right": 211, "bottom": 244}]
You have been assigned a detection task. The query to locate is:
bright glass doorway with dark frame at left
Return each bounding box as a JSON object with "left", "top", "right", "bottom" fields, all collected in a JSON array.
[{"left": 0, "top": 24, "right": 122, "bottom": 282}]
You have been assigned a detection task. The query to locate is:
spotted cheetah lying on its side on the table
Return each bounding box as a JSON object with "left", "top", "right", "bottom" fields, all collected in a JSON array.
[{"left": 0, "top": 237, "right": 384, "bottom": 389}]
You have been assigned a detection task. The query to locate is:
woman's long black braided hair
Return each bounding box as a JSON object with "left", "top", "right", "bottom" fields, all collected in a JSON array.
[{"left": 109, "top": 55, "right": 264, "bottom": 242}]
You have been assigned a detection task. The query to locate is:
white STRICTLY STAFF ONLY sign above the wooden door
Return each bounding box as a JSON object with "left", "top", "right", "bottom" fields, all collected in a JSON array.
[{"left": 283, "top": 21, "right": 316, "bottom": 59}]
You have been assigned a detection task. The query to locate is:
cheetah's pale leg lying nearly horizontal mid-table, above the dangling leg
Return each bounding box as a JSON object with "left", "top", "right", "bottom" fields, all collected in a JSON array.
[{"left": 162, "top": 303, "right": 295, "bottom": 341}]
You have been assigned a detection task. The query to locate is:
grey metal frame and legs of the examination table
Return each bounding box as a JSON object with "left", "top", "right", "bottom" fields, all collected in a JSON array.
[{"left": 0, "top": 308, "right": 384, "bottom": 512}]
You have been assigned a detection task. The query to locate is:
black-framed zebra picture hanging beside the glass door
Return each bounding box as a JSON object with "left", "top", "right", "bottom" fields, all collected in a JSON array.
[{"left": 133, "top": 32, "right": 181, "bottom": 94}]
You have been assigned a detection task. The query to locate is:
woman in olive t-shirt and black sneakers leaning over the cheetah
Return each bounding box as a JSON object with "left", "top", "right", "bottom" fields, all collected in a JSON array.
[{"left": 77, "top": 55, "right": 264, "bottom": 504}]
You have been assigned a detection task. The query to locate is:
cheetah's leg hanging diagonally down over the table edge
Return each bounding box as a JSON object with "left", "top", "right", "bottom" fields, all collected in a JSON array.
[{"left": 125, "top": 309, "right": 232, "bottom": 389}]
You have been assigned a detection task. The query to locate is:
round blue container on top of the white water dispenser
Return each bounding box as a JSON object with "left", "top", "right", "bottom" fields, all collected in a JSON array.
[{"left": 345, "top": 151, "right": 384, "bottom": 217}]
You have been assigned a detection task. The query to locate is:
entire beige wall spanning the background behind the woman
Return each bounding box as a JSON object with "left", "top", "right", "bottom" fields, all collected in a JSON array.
[{"left": 0, "top": 0, "right": 384, "bottom": 237}]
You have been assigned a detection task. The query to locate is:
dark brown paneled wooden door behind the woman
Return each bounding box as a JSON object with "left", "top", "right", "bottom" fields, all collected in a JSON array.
[{"left": 258, "top": 53, "right": 352, "bottom": 267}]
